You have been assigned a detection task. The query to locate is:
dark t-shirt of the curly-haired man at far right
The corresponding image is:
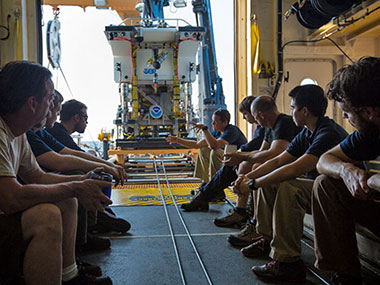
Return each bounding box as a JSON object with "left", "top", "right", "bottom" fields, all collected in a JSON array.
[{"left": 340, "top": 131, "right": 380, "bottom": 161}]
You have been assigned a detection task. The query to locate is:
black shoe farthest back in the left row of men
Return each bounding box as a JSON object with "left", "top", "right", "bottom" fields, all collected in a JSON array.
[{"left": 89, "top": 210, "right": 131, "bottom": 234}]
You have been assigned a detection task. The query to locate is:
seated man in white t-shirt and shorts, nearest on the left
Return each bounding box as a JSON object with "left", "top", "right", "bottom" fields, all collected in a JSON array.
[{"left": 0, "top": 61, "right": 112, "bottom": 285}]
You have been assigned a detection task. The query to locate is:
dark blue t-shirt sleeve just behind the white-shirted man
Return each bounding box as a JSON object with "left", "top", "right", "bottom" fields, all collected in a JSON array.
[{"left": 26, "top": 130, "right": 65, "bottom": 157}]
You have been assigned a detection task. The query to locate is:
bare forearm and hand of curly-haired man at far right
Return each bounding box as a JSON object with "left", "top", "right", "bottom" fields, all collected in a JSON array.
[{"left": 317, "top": 145, "right": 375, "bottom": 200}]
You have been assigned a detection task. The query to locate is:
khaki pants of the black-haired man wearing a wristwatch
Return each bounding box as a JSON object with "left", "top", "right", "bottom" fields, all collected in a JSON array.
[{"left": 256, "top": 179, "right": 314, "bottom": 262}]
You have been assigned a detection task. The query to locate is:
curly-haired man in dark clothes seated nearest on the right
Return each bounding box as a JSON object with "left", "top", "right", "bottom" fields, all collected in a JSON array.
[{"left": 312, "top": 57, "right": 380, "bottom": 285}]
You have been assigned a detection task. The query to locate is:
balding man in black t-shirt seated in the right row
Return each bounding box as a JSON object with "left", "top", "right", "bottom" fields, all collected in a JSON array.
[{"left": 181, "top": 95, "right": 300, "bottom": 227}]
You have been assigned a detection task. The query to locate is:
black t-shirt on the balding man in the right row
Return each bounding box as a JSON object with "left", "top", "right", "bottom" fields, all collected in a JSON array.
[{"left": 264, "top": 114, "right": 302, "bottom": 145}]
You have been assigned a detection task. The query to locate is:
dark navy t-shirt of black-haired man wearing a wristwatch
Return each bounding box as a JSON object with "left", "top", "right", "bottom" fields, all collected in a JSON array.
[{"left": 286, "top": 117, "right": 348, "bottom": 179}]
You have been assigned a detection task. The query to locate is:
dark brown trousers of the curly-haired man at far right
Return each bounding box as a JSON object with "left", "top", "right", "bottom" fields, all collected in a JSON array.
[{"left": 312, "top": 175, "right": 380, "bottom": 276}]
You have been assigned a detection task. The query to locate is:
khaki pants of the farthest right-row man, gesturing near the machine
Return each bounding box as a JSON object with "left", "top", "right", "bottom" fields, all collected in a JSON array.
[{"left": 194, "top": 146, "right": 224, "bottom": 183}]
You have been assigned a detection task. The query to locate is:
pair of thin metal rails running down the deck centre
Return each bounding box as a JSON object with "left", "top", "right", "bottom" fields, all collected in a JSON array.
[{"left": 153, "top": 158, "right": 212, "bottom": 285}]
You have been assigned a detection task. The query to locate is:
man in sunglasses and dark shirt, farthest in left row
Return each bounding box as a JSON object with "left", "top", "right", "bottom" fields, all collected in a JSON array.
[{"left": 44, "top": 96, "right": 131, "bottom": 233}]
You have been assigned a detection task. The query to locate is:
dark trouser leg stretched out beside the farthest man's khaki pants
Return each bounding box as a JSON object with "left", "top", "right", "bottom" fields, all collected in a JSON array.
[{"left": 199, "top": 165, "right": 237, "bottom": 201}]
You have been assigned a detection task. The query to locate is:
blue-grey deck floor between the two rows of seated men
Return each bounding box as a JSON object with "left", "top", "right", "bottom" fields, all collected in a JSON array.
[{"left": 83, "top": 204, "right": 325, "bottom": 285}]
